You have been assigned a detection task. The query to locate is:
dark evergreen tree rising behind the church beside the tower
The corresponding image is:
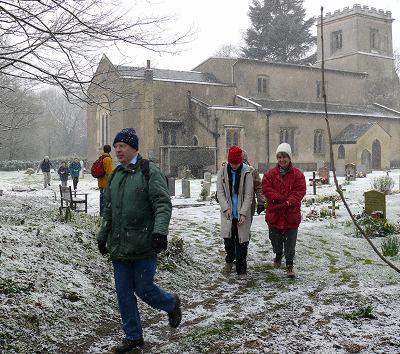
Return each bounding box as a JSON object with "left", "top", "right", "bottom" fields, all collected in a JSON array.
[{"left": 242, "top": 0, "right": 316, "bottom": 64}]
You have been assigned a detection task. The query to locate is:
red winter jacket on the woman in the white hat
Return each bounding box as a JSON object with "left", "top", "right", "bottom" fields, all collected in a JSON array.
[{"left": 262, "top": 164, "right": 306, "bottom": 230}]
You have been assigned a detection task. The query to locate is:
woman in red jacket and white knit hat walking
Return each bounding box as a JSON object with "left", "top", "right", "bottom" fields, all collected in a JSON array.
[{"left": 262, "top": 143, "right": 306, "bottom": 278}]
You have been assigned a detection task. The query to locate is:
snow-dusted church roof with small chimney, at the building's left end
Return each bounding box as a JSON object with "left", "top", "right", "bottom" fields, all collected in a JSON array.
[{"left": 116, "top": 65, "right": 222, "bottom": 84}]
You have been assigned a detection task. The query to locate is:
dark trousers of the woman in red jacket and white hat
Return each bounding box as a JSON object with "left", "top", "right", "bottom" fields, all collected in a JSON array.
[{"left": 269, "top": 227, "right": 298, "bottom": 266}]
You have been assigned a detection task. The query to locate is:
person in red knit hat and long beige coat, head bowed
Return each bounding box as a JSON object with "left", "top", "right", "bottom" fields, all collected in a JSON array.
[{"left": 217, "top": 145, "right": 254, "bottom": 279}]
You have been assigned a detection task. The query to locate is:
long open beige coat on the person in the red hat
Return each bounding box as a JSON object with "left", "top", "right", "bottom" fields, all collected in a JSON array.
[{"left": 217, "top": 163, "right": 254, "bottom": 243}]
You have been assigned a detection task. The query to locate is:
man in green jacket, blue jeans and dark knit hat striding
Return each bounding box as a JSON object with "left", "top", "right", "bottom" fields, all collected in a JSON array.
[{"left": 97, "top": 128, "right": 182, "bottom": 353}]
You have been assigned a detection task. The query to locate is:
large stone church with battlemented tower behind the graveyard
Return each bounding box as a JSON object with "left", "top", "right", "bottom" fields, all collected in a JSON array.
[{"left": 87, "top": 5, "right": 400, "bottom": 175}]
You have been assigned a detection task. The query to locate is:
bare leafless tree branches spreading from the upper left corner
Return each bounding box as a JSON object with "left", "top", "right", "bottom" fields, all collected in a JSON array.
[{"left": 0, "top": 0, "right": 185, "bottom": 102}]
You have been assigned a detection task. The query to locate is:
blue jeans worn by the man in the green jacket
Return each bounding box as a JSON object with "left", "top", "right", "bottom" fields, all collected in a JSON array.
[{"left": 113, "top": 256, "right": 176, "bottom": 340}]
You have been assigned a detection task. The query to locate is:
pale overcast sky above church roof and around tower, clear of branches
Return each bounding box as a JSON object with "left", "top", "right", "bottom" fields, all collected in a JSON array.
[{"left": 105, "top": 0, "right": 400, "bottom": 70}]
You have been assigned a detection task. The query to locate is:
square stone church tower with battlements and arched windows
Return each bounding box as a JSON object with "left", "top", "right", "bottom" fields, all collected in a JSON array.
[{"left": 317, "top": 4, "right": 395, "bottom": 81}]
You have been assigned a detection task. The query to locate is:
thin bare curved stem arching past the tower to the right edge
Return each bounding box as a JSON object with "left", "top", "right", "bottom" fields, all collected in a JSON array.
[{"left": 321, "top": 6, "right": 400, "bottom": 273}]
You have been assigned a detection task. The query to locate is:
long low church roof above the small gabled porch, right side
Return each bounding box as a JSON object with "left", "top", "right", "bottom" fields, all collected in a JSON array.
[{"left": 252, "top": 99, "right": 400, "bottom": 119}]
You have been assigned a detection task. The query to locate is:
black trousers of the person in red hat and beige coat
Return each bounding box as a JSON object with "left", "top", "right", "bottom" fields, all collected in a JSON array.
[{"left": 224, "top": 219, "right": 249, "bottom": 274}]
